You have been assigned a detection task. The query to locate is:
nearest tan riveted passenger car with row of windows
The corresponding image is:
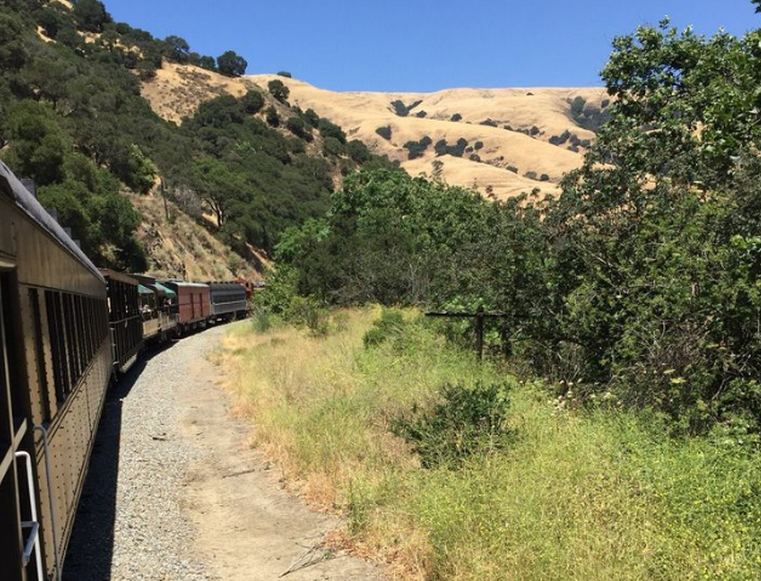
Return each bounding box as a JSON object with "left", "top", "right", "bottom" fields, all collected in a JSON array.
[{"left": 0, "top": 163, "right": 113, "bottom": 581}]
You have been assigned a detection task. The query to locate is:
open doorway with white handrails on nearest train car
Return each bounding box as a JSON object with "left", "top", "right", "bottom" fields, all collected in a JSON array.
[{"left": 0, "top": 265, "right": 42, "bottom": 581}]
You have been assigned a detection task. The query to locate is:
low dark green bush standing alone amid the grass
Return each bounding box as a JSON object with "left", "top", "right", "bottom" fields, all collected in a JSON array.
[{"left": 392, "top": 383, "right": 512, "bottom": 468}]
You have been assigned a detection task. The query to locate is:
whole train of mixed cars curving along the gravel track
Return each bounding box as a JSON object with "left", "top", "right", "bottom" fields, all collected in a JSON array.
[{"left": 0, "top": 162, "right": 253, "bottom": 581}]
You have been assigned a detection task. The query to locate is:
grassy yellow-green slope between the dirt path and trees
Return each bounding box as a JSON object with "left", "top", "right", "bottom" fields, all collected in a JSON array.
[{"left": 217, "top": 310, "right": 761, "bottom": 579}]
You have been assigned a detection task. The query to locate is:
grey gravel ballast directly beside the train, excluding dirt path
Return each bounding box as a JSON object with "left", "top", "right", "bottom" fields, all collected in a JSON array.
[{"left": 64, "top": 328, "right": 224, "bottom": 581}]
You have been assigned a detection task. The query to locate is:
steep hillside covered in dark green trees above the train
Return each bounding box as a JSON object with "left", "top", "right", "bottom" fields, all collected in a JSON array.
[{"left": 0, "top": 0, "right": 392, "bottom": 278}]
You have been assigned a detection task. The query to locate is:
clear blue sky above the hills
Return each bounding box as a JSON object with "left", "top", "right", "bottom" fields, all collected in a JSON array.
[{"left": 106, "top": 0, "right": 761, "bottom": 91}]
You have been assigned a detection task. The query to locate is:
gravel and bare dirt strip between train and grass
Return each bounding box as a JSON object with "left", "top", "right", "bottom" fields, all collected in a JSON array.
[{"left": 64, "top": 328, "right": 381, "bottom": 581}]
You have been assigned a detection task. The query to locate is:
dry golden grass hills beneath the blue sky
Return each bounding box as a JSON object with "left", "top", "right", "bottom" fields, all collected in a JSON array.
[{"left": 143, "top": 63, "right": 607, "bottom": 198}]
